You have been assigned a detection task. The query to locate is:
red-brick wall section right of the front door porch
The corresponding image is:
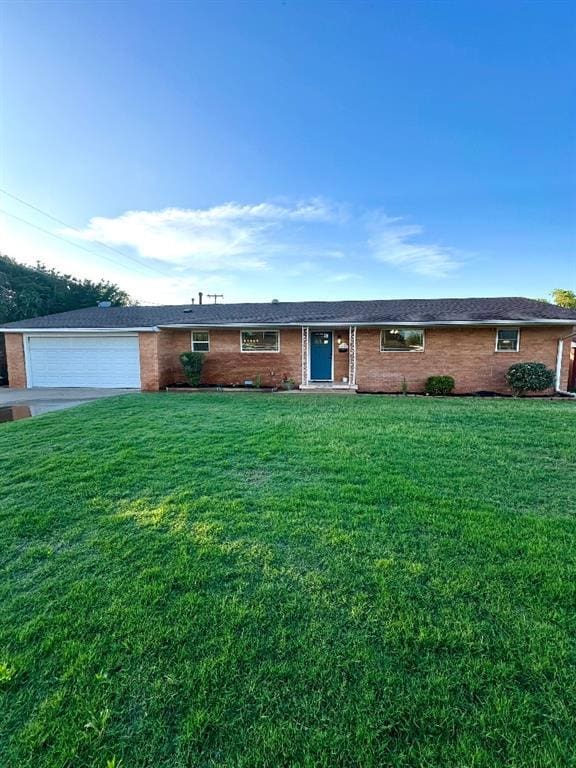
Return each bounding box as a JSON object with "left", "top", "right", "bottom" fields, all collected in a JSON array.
[{"left": 356, "top": 327, "right": 571, "bottom": 393}]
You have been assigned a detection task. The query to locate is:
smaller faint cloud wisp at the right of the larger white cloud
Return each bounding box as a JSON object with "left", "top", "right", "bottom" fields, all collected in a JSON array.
[{"left": 368, "top": 214, "right": 458, "bottom": 277}]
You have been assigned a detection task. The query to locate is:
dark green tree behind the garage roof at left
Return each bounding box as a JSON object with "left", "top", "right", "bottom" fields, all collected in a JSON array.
[{"left": 0, "top": 254, "right": 134, "bottom": 323}]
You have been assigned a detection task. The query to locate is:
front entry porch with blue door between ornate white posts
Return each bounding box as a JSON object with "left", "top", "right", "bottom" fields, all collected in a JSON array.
[{"left": 300, "top": 325, "right": 358, "bottom": 391}]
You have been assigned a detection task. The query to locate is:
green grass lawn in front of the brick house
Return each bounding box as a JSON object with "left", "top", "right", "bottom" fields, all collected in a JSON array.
[{"left": 0, "top": 394, "right": 576, "bottom": 768}]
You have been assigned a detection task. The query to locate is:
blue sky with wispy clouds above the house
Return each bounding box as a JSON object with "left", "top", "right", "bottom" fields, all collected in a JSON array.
[{"left": 0, "top": 0, "right": 576, "bottom": 303}]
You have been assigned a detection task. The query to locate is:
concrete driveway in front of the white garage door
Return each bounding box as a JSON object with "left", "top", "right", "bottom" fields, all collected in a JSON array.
[{"left": 0, "top": 387, "right": 140, "bottom": 422}]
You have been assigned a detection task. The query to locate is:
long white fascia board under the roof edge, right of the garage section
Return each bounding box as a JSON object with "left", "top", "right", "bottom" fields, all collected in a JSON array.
[{"left": 158, "top": 320, "right": 574, "bottom": 330}]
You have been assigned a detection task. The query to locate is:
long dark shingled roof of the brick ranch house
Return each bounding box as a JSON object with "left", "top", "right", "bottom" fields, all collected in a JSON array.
[{"left": 0, "top": 296, "right": 576, "bottom": 330}]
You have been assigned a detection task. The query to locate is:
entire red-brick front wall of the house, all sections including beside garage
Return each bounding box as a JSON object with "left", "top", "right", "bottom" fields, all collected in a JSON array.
[{"left": 6, "top": 326, "right": 572, "bottom": 393}]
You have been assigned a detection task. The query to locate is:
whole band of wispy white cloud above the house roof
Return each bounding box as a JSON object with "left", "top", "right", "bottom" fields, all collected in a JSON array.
[{"left": 55, "top": 198, "right": 460, "bottom": 282}]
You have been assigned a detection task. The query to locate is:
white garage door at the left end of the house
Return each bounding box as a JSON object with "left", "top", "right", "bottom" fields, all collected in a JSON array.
[{"left": 27, "top": 335, "right": 140, "bottom": 388}]
